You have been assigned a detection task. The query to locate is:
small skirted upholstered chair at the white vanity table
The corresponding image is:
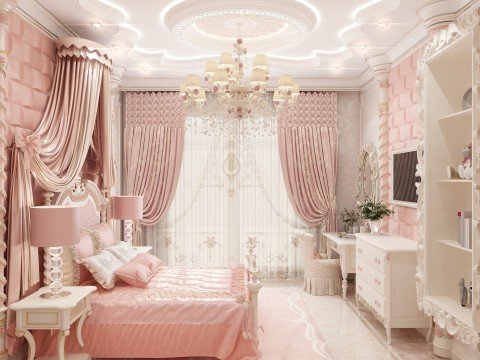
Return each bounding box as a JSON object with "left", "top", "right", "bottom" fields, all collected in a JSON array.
[{"left": 298, "top": 232, "right": 342, "bottom": 295}]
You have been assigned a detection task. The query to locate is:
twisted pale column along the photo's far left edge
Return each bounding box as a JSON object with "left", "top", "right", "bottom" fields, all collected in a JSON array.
[{"left": 0, "top": 0, "right": 17, "bottom": 360}]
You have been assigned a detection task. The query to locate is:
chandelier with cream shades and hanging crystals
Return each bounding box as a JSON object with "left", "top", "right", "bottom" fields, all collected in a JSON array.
[{"left": 180, "top": 38, "right": 300, "bottom": 136}]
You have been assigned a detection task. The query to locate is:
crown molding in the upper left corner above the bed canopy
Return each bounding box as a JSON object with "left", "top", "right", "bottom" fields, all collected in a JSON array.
[{"left": 14, "top": 0, "right": 78, "bottom": 40}]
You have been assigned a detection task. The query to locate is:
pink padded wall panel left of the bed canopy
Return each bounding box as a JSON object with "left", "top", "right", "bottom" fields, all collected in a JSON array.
[{"left": 5, "top": 13, "right": 55, "bottom": 142}]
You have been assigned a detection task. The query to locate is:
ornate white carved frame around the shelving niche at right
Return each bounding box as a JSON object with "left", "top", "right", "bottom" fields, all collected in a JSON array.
[{"left": 415, "top": 6, "right": 480, "bottom": 347}]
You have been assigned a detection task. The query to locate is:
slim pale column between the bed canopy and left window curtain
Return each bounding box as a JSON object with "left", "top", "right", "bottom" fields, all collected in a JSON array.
[{"left": 110, "top": 66, "right": 125, "bottom": 241}]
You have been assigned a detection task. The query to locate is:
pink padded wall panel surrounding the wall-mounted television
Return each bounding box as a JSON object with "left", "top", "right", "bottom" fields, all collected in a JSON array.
[{"left": 388, "top": 54, "right": 418, "bottom": 240}]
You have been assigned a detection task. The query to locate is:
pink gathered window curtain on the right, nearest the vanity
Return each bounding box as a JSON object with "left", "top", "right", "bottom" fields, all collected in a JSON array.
[{"left": 278, "top": 92, "right": 338, "bottom": 231}]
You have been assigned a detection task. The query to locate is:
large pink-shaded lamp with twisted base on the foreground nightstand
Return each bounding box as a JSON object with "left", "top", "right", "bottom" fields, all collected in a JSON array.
[{"left": 30, "top": 206, "right": 80, "bottom": 298}]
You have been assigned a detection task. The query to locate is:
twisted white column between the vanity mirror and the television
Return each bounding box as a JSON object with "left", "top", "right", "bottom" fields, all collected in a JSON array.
[{"left": 368, "top": 55, "right": 391, "bottom": 232}]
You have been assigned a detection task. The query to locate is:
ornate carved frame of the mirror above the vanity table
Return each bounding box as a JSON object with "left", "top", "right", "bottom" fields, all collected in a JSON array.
[{"left": 355, "top": 144, "right": 378, "bottom": 202}]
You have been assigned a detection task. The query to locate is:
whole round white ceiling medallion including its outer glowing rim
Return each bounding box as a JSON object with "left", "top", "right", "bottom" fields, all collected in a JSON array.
[{"left": 161, "top": 0, "right": 320, "bottom": 51}]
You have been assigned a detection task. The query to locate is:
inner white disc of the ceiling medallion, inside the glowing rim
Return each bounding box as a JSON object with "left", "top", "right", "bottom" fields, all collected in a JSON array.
[{"left": 171, "top": 8, "right": 311, "bottom": 51}]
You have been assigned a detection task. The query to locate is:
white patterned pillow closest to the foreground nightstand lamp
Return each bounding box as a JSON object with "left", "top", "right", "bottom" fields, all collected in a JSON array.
[{"left": 82, "top": 250, "right": 123, "bottom": 290}]
